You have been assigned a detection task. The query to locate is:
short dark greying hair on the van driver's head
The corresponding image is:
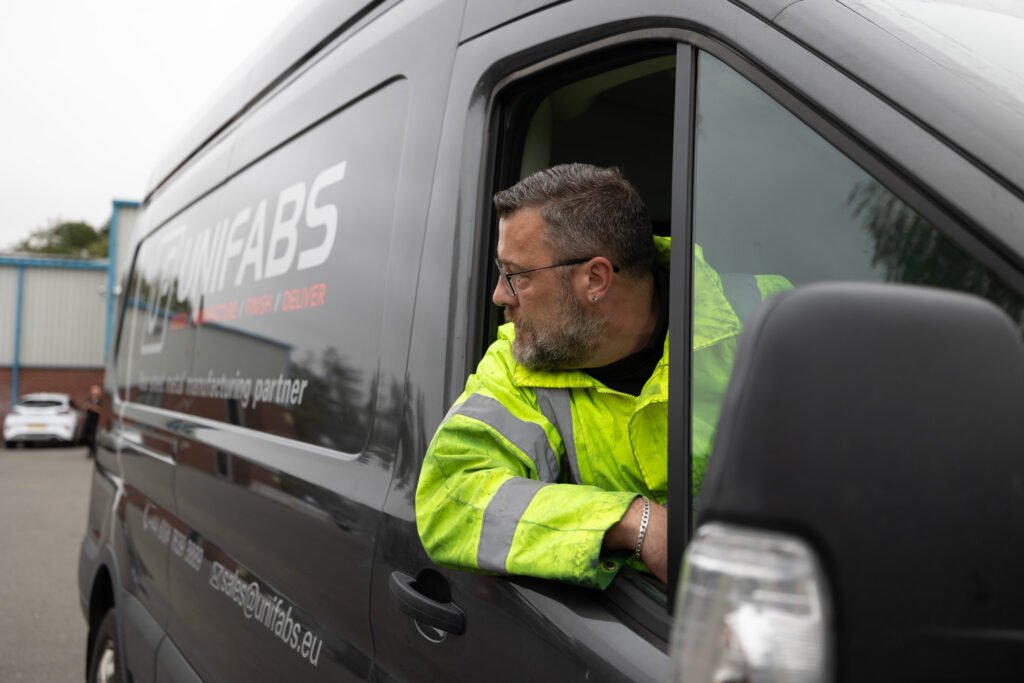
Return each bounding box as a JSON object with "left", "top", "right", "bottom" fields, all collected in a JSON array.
[{"left": 495, "top": 164, "right": 654, "bottom": 278}]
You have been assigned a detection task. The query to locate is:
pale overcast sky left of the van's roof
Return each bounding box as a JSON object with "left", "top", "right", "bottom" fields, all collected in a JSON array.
[{"left": 0, "top": 0, "right": 301, "bottom": 251}]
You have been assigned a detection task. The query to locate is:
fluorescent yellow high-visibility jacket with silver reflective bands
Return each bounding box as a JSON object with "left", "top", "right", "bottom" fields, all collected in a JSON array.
[{"left": 416, "top": 238, "right": 784, "bottom": 588}]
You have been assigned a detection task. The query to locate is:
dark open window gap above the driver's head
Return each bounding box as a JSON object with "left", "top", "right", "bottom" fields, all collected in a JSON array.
[{"left": 487, "top": 44, "right": 676, "bottom": 355}]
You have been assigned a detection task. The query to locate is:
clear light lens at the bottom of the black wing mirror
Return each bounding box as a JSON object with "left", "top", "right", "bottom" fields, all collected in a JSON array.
[{"left": 672, "top": 523, "right": 833, "bottom": 683}]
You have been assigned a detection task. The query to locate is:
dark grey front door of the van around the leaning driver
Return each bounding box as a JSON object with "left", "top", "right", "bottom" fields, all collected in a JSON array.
[{"left": 373, "top": 0, "right": 1020, "bottom": 680}]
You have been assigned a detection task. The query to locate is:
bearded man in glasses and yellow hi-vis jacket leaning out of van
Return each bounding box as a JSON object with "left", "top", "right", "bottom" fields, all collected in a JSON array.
[{"left": 416, "top": 164, "right": 782, "bottom": 588}]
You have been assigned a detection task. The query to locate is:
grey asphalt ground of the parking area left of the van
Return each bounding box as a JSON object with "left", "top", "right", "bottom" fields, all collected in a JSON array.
[{"left": 0, "top": 447, "right": 92, "bottom": 682}]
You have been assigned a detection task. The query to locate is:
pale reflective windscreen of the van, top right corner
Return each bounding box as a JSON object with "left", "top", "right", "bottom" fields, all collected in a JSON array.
[{"left": 746, "top": 0, "right": 1024, "bottom": 198}]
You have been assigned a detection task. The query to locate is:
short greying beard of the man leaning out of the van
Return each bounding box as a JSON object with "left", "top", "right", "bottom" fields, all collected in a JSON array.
[{"left": 505, "top": 284, "right": 605, "bottom": 372}]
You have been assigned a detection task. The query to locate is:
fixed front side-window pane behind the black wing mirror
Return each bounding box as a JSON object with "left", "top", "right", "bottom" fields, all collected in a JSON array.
[{"left": 692, "top": 53, "right": 1022, "bottom": 491}]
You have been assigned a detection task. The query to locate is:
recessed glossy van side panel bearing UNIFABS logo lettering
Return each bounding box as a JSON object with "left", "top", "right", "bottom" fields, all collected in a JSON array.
[{"left": 124, "top": 82, "right": 407, "bottom": 453}]
